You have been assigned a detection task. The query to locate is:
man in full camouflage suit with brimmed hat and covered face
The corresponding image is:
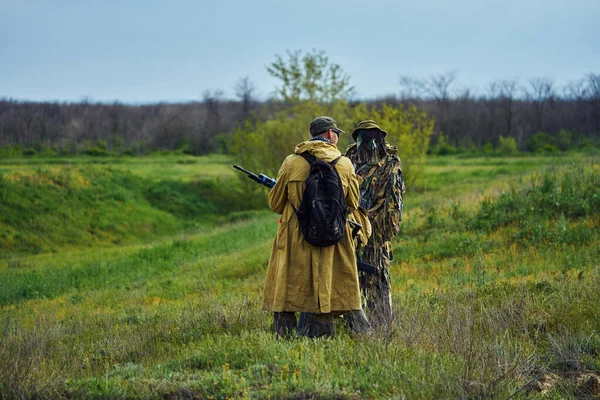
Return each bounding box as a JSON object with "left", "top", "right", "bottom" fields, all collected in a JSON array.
[{"left": 345, "top": 120, "right": 405, "bottom": 329}]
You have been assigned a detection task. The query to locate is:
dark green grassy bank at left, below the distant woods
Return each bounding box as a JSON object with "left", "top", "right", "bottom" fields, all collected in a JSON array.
[{"left": 0, "top": 156, "right": 251, "bottom": 258}]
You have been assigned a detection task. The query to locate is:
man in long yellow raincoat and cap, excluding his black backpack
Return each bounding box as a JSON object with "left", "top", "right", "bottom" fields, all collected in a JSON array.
[{"left": 263, "top": 116, "right": 370, "bottom": 337}]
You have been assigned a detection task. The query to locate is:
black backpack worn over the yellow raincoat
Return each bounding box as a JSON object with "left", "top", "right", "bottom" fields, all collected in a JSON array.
[{"left": 292, "top": 152, "right": 348, "bottom": 247}]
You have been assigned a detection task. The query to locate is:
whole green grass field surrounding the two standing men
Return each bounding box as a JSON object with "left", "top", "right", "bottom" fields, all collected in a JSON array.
[{"left": 0, "top": 154, "right": 600, "bottom": 399}]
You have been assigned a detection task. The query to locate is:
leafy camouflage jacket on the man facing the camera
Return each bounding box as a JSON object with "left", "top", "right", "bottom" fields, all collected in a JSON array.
[{"left": 345, "top": 143, "right": 405, "bottom": 244}]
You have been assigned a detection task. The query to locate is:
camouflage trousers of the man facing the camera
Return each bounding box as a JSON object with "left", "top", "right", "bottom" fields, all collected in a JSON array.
[{"left": 358, "top": 243, "right": 393, "bottom": 330}]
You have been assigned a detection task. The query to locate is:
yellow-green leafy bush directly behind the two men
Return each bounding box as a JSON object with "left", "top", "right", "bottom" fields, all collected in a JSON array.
[{"left": 230, "top": 101, "right": 433, "bottom": 190}]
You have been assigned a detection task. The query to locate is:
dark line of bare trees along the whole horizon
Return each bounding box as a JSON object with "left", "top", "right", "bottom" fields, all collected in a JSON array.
[{"left": 0, "top": 64, "right": 600, "bottom": 156}]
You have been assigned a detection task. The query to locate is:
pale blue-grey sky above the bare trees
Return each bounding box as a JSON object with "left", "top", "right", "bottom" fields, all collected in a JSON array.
[{"left": 0, "top": 0, "right": 600, "bottom": 103}]
